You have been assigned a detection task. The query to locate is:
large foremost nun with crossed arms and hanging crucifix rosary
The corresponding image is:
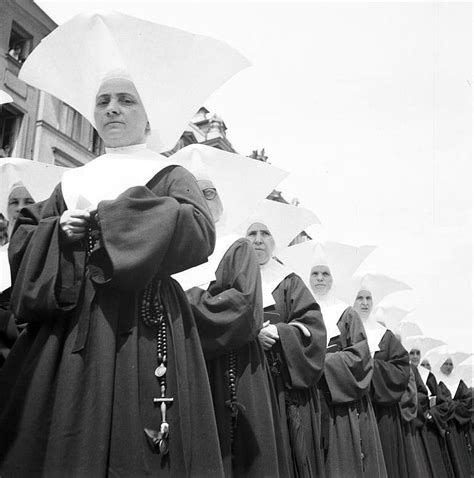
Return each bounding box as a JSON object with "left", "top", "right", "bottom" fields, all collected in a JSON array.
[{"left": 0, "top": 13, "right": 250, "bottom": 477}]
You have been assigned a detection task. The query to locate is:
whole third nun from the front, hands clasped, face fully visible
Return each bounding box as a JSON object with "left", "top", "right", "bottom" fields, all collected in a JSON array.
[{"left": 246, "top": 201, "right": 326, "bottom": 477}]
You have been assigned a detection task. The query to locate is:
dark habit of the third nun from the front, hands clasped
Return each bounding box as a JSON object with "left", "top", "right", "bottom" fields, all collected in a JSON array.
[{"left": 265, "top": 274, "right": 326, "bottom": 477}]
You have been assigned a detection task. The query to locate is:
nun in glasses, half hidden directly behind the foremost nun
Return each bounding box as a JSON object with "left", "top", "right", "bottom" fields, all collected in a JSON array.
[{"left": 170, "top": 145, "right": 289, "bottom": 478}]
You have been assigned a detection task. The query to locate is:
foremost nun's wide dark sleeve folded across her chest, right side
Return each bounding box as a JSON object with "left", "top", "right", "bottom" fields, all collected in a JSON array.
[{"left": 89, "top": 166, "right": 215, "bottom": 290}]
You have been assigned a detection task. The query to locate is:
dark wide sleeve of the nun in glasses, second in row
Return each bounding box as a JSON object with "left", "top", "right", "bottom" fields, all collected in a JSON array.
[{"left": 186, "top": 239, "right": 263, "bottom": 359}]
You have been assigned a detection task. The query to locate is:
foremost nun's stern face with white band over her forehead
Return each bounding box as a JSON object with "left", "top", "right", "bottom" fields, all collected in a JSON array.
[{"left": 94, "top": 78, "right": 148, "bottom": 148}]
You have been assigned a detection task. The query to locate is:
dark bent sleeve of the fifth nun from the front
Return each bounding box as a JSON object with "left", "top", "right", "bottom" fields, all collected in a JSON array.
[{"left": 371, "top": 330, "right": 410, "bottom": 405}]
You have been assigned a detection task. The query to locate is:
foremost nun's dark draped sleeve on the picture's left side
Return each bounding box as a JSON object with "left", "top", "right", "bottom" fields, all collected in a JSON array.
[{"left": 9, "top": 186, "right": 85, "bottom": 322}]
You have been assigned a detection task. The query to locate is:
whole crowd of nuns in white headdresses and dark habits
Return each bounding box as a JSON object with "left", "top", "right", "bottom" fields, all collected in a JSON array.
[{"left": 0, "top": 7, "right": 474, "bottom": 478}]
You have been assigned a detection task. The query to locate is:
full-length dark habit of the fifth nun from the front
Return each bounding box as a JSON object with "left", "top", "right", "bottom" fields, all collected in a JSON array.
[{"left": 370, "top": 329, "right": 410, "bottom": 478}]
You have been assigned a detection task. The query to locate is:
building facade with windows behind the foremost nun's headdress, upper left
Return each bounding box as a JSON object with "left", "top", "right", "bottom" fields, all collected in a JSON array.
[{"left": 0, "top": 0, "right": 103, "bottom": 167}]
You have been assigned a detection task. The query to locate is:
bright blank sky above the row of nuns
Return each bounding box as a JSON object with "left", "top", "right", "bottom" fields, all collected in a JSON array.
[{"left": 37, "top": 0, "right": 473, "bottom": 352}]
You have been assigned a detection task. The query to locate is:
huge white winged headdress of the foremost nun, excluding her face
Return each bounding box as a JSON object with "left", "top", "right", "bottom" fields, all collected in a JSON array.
[{"left": 19, "top": 12, "right": 250, "bottom": 152}]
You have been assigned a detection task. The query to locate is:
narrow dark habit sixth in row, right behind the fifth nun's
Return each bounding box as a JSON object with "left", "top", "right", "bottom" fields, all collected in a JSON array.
[{"left": 400, "top": 365, "right": 433, "bottom": 478}]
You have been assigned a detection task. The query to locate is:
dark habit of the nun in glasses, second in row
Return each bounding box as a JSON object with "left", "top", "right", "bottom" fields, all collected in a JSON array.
[{"left": 186, "top": 239, "right": 289, "bottom": 478}]
